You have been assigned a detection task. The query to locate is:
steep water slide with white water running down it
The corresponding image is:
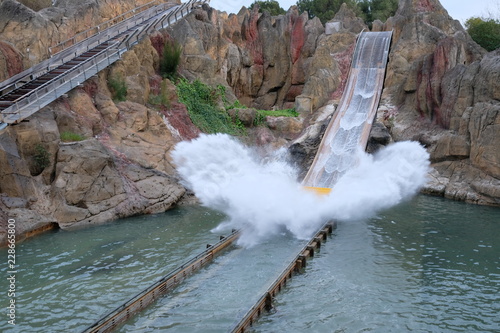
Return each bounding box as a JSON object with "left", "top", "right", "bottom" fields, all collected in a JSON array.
[{"left": 302, "top": 31, "right": 392, "bottom": 189}]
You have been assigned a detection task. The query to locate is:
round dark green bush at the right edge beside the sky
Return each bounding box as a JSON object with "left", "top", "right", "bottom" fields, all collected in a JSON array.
[{"left": 465, "top": 17, "right": 500, "bottom": 51}]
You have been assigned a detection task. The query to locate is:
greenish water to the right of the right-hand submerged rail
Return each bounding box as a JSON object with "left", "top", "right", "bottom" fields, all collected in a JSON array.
[{"left": 254, "top": 196, "right": 500, "bottom": 332}]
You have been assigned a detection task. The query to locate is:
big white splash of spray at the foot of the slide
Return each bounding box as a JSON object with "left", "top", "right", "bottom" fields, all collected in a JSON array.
[{"left": 172, "top": 134, "right": 429, "bottom": 246}]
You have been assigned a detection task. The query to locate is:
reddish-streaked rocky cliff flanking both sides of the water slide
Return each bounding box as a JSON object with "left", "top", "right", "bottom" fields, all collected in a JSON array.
[{"left": 174, "top": 0, "right": 500, "bottom": 205}]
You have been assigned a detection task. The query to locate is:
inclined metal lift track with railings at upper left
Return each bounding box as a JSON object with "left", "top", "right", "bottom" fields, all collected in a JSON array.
[{"left": 0, "top": 0, "right": 209, "bottom": 130}]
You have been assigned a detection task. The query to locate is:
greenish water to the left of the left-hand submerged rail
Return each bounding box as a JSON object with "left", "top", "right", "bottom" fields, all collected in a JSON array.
[{"left": 0, "top": 206, "right": 225, "bottom": 333}]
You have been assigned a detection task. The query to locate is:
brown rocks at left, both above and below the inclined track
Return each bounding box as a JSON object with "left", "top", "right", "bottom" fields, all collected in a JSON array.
[{"left": 0, "top": 0, "right": 190, "bottom": 243}]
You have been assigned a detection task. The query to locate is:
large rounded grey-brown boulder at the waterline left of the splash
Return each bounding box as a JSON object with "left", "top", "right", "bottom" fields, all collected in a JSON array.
[{"left": 52, "top": 139, "right": 185, "bottom": 228}]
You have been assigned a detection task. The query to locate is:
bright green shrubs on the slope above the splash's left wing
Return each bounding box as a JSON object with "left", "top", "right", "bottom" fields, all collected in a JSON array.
[{"left": 177, "top": 79, "right": 244, "bottom": 135}]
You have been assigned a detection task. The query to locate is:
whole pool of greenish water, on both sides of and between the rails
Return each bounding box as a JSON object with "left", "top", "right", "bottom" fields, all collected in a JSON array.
[{"left": 0, "top": 196, "right": 500, "bottom": 332}]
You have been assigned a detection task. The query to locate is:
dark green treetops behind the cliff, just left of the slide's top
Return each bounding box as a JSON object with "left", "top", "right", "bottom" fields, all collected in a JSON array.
[{"left": 297, "top": 0, "right": 360, "bottom": 24}]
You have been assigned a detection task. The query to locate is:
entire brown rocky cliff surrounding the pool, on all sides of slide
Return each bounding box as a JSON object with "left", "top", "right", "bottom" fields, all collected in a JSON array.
[{"left": 0, "top": 0, "right": 500, "bottom": 244}]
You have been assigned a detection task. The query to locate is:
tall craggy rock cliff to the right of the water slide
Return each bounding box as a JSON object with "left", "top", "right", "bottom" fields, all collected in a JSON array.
[{"left": 381, "top": 0, "right": 500, "bottom": 205}]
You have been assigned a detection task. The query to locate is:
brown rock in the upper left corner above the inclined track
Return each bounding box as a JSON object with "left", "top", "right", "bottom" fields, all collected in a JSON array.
[{"left": 0, "top": 0, "right": 160, "bottom": 77}]
